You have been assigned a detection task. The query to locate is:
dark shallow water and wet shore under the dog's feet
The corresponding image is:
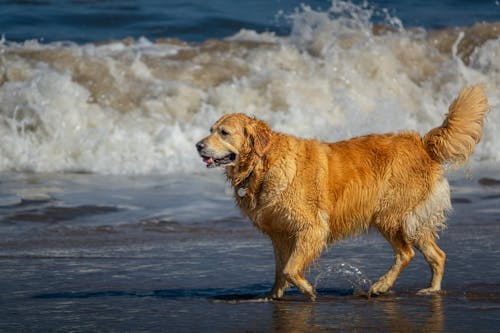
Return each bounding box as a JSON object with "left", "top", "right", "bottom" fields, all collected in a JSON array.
[{"left": 0, "top": 170, "right": 500, "bottom": 332}]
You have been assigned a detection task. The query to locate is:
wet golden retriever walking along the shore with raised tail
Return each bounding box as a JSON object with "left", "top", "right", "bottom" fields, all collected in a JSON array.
[{"left": 196, "top": 86, "right": 490, "bottom": 301}]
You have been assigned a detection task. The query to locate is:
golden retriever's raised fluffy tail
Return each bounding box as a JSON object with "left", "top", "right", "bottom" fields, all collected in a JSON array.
[{"left": 423, "top": 85, "right": 490, "bottom": 166}]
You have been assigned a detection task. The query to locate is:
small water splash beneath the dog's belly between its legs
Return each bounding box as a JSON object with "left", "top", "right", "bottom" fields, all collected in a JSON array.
[{"left": 314, "top": 263, "right": 372, "bottom": 295}]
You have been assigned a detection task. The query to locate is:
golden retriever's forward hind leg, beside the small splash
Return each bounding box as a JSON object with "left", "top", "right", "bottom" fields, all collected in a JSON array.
[{"left": 370, "top": 230, "right": 415, "bottom": 295}]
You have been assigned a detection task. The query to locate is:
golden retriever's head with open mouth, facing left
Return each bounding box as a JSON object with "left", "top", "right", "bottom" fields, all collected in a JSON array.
[{"left": 196, "top": 113, "right": 271, "bottom": 168}]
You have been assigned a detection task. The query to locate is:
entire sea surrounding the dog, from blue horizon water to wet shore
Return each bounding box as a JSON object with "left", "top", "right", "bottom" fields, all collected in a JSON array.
[{"left": 0, "top": 0, "right": 500, "bottom": 332}]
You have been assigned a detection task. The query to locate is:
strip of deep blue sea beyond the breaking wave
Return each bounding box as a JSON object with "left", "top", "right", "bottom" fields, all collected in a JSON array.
[{"left": 0, "top": 0, "right": 500, "bottom": 43}]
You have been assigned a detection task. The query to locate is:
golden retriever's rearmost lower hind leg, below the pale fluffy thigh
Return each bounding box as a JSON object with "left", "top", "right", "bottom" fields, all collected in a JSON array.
[{"left": 414, "top": 236, "right": 446, "bottom": 294}]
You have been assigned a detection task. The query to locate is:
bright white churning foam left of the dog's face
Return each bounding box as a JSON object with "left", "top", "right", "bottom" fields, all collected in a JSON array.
[{"left": 0, "top": 64, "right": 208, "bottom": 174}]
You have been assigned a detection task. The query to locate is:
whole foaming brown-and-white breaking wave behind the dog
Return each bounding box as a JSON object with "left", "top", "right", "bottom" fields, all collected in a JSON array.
[{"left": 0, "top": 1, "right": 500, "bottom": 174}]
